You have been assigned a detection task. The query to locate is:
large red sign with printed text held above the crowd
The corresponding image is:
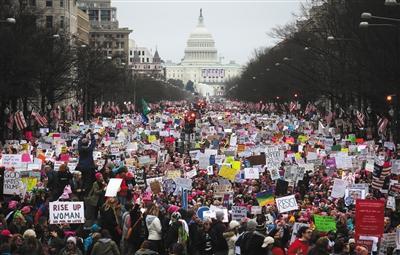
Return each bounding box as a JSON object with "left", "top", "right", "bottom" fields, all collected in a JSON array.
[{"left": 356, "top": 199, "right": 385, "bottom": 237}]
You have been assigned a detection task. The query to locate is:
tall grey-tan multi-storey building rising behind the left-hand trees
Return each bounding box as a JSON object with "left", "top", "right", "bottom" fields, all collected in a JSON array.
[{"left": 78, "top": 0, "right": 132, "bottom": 64}]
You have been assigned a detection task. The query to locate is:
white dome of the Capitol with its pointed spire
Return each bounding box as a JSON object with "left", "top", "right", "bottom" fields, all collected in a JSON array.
[{"left": 182, "top": 9, "right": 218, "bottom": 65}]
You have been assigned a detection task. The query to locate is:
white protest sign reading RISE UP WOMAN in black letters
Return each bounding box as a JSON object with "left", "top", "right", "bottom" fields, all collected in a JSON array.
[{"left": 49, "top": 201, "right": 85, "bottom": 224}]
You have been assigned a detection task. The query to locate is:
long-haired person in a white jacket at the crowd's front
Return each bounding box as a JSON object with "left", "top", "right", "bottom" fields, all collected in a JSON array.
[{"left": 146, "top": 204, "right": 162, "bottom": 253}]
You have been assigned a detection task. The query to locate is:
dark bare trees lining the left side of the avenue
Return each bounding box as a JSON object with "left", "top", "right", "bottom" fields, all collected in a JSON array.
[{"left": 0, "top": 0, "right": 188, "bottom": 131}]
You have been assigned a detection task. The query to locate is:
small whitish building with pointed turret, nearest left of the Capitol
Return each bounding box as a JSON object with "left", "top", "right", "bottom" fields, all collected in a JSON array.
[{"left": 129, "top": 39, "right": 165, "bottom": 79}]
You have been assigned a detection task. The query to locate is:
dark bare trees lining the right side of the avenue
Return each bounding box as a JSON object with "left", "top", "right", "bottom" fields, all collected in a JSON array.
[{"left": 226, "top": 0, "right": 400, "bottom": 115}]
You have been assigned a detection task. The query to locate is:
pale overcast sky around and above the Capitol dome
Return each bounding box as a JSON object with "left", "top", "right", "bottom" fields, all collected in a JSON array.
[{"left": 112, "top": 0, "right": 304, "bottom": 64}]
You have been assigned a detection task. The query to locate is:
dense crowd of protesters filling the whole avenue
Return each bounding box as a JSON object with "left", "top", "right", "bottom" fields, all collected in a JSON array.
[{"left": 0, "top": 101, "right": 400, "bottom": 255}]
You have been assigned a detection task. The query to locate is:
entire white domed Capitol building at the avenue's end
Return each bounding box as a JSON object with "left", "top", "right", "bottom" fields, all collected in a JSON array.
[{"left": 165, "top": 9, "right": 241, "bottom": 97}]
